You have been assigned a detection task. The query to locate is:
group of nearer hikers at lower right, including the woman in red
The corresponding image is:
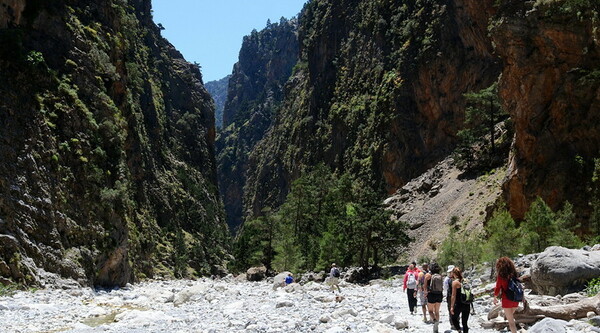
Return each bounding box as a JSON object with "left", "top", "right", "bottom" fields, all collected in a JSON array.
[{"left": 403, "top": 257, "right": 523, "bottom": 333}]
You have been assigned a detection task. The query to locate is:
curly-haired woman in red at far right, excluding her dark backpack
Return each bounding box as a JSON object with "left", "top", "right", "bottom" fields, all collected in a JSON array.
[{"left": 494, "top": 257, "right": 519, "bottom": 333}]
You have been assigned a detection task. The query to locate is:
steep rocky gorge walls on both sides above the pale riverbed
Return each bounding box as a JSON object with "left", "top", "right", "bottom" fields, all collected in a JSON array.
[{"left": 0, "top": 0, "right": 600, "bottom": 286}]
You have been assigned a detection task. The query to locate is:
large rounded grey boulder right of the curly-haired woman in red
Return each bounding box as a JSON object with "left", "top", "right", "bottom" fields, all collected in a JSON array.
[{"left": 531, "top": 246, "right": 600, "bottom": 295}]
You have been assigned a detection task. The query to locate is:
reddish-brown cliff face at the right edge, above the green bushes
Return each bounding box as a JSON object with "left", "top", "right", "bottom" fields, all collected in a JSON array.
[{"left": 492, "top": 1, "right": 600, "bottom": 218}]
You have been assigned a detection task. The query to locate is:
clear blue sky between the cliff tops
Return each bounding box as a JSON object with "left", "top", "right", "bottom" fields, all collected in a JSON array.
[{"left": 152, "top": 0, "right": 307, "bottom": 82}]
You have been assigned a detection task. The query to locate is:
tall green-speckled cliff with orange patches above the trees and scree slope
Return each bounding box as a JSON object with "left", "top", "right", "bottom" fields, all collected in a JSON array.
[{"left": 245, "top": 0, "right": 500, "bottom": 215}]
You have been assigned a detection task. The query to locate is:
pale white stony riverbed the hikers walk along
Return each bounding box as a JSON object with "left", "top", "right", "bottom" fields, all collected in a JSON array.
[{"left": 0, "top": 277, "right": 594, "bottom": 333}]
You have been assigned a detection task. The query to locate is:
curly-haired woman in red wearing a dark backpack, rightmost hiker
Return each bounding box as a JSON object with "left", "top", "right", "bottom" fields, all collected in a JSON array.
[{"left": 494, "top": 257, "right": 523, "bottom": 333}]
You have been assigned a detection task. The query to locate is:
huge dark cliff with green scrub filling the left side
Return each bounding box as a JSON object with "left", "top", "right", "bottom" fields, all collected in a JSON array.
[{"left": 0, "top": 0, "right": 228, "bottom": 286}]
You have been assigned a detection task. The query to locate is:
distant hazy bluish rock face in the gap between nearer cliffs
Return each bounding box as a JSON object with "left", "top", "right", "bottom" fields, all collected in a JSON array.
[{"left": 216, "top": 19, "right": 298, "bottom": 230}]
